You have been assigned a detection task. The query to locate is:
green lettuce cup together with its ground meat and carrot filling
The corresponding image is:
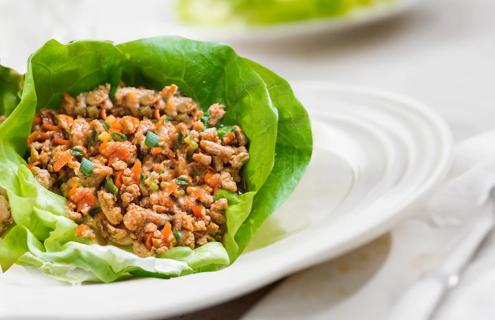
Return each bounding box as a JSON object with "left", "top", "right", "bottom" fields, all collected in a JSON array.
[{"left": 0, "top": 37, "right": 312, "bottom": 283}]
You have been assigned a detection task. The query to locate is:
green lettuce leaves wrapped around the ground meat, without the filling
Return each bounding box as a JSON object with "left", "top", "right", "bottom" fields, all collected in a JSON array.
[{"left": 0, "top": 37, "right": 312, "bottom": 283}]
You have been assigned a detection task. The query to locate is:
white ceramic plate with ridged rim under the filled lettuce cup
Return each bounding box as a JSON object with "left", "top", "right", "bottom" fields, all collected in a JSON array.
[{"left": 0, "top": 82, "right": 451, "bottom": 319}]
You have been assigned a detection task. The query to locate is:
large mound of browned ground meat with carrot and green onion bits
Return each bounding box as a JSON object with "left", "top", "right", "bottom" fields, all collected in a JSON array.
[{"left": 28, "top": 85, "right": 249, "bottom": 256}]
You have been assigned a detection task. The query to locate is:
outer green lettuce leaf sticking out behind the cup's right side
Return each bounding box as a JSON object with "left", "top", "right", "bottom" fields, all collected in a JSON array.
[{"left": 235, "top": 60, "right": 313, "bottom": 252}]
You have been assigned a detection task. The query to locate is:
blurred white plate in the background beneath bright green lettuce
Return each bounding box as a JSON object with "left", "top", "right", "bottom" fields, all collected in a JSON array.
[{"left": 172, "top": 0, "right": 420, "bottom": 43}]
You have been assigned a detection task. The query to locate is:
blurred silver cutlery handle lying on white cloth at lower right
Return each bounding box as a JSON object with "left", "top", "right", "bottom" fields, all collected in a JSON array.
[{"left": 389, "top": 188, "right": 495, "bottom": 320}]
